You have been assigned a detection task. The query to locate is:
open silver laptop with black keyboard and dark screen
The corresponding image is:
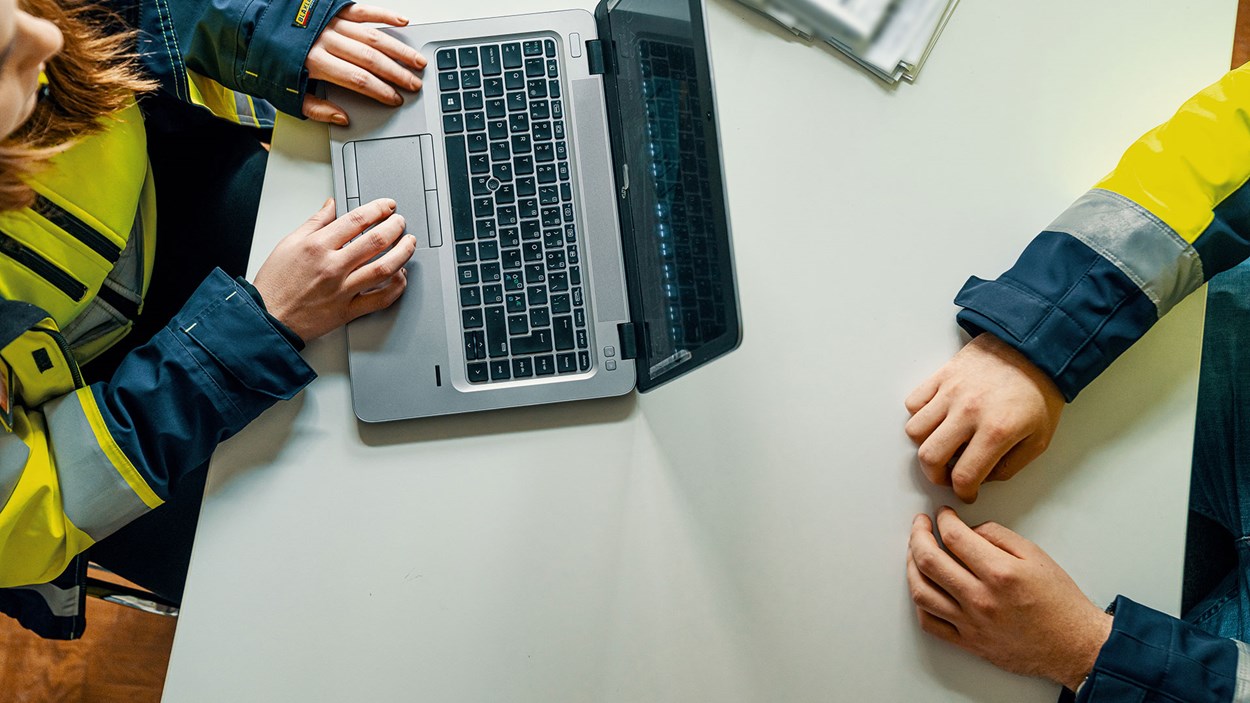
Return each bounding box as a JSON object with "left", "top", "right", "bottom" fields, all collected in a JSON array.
[{"left": 328, "top": 0, "right": 741, "bottom": 423}]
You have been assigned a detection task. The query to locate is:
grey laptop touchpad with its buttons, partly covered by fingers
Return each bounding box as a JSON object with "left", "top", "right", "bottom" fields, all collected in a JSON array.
[{"left": 353, "top": 135, "right": 443, "bottom": 246}]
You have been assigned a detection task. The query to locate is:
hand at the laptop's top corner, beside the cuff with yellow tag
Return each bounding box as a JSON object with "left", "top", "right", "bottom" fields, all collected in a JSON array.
[{"left": 304, "top": 5, "right": 426, "bottom": 126}]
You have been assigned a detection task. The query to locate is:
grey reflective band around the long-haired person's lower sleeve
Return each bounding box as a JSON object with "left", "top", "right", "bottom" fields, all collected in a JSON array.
[{"left": 44, "top": 390, "right": 149, "bottom": 542}]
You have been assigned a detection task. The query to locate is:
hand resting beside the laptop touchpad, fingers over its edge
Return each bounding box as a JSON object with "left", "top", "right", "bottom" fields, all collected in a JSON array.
[{"left": 255, "top": 199, "right": 416, "bottom": 341}]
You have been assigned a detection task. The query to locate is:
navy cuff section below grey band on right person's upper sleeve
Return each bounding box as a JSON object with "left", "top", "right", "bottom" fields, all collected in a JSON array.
[{"left": 955, "top": 231, "right": 1159, "bottom": 400}]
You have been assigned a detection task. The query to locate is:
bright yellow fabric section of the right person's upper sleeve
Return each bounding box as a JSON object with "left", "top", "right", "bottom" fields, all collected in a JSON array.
[{"left": 1095, "top": 66, "right": 1250, "bottom": 244}]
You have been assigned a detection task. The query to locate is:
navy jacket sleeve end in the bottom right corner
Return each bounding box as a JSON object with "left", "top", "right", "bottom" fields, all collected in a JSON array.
[{"left": 1075, "top": 595, "right": 1250, "bottom": 703}]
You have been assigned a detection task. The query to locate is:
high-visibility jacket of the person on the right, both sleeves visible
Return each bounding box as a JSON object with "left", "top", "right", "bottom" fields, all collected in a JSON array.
[{"left": 955, "top": 66, "right": 1250, "bottom": 703}]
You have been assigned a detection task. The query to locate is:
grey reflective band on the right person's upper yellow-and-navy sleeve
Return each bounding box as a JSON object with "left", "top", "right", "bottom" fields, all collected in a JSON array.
[{"left": 1046, "top": 189, "right": 1204, "bottom": 318}]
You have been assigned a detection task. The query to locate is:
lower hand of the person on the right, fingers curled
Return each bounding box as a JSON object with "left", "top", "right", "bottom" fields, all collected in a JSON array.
[{"left": 908, "top": 508, "right": 1111, "bottom": 690}]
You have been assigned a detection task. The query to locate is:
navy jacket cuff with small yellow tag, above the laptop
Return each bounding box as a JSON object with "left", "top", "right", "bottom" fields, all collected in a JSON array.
[{"left": 236, "top": 0, "right": 353, "bottom": 118}]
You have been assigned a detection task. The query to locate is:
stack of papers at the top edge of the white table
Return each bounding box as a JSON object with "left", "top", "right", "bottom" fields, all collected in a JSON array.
[{"left": 741, "top": 0, "right": 959, "bottom": 83}]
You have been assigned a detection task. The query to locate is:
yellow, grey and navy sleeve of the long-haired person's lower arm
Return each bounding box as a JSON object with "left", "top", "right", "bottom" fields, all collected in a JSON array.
[{"left": 0, "top": 270, "right": 315, "bottom": 587}]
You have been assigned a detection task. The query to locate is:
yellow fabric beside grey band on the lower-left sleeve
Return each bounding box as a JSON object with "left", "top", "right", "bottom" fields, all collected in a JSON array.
[{"left": 0, "top": 407, "right": 95, "bottom": 588}]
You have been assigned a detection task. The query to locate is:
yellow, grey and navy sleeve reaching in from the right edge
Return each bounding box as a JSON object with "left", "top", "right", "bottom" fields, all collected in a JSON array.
[{"left": 955, "top": 66, "right": 1250, "bottom": 400}]
